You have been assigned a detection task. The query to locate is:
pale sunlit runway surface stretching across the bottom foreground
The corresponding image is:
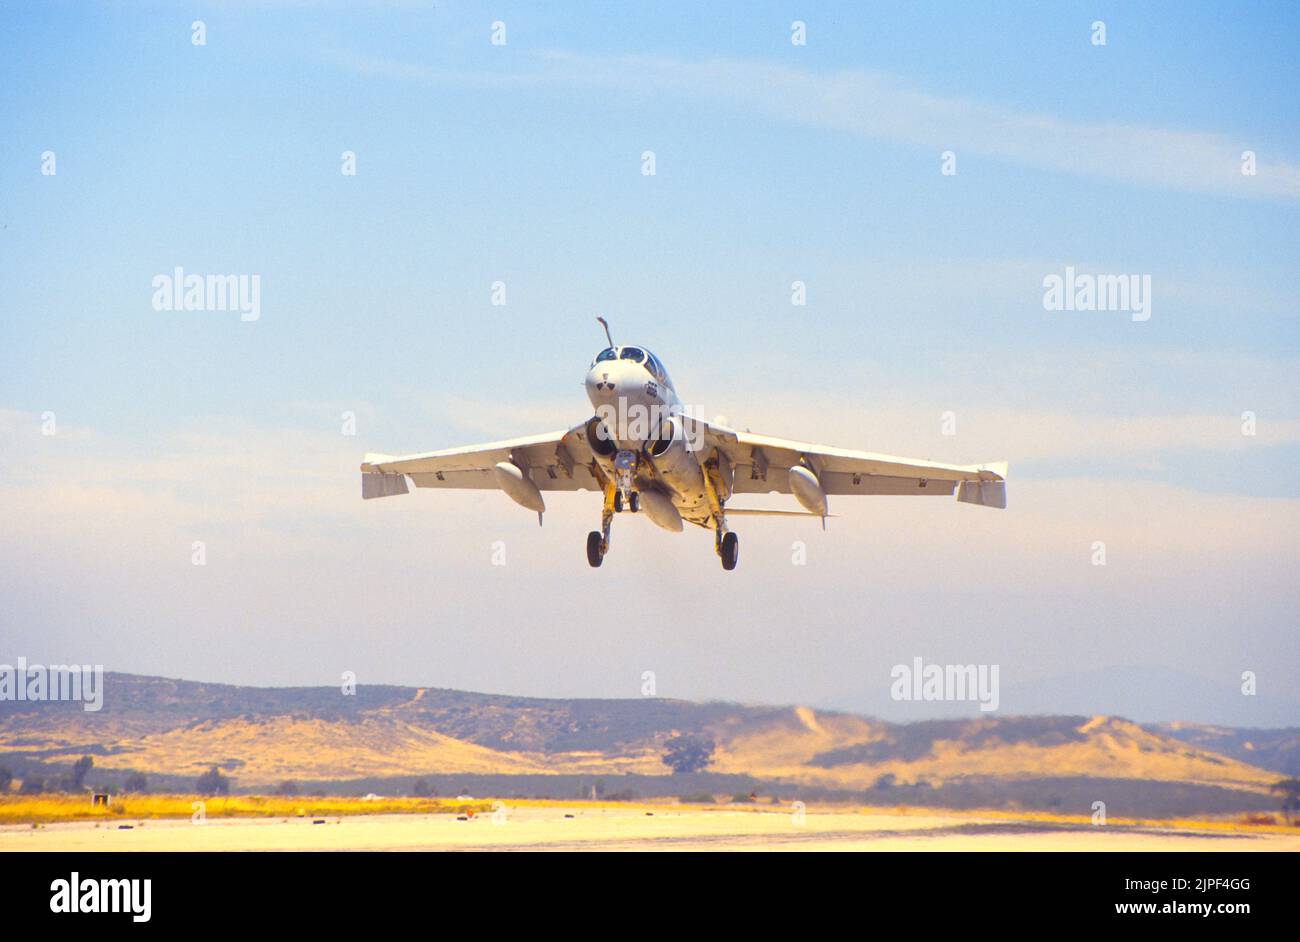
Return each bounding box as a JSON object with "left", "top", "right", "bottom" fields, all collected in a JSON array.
[{"left": 0, "top": 803, "right": 1300, "bottom": 852}]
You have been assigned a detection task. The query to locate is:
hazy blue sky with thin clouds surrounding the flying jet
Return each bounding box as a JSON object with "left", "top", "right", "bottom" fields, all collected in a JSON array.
[{"left": 0, "top": 3, "right": 1300, "bottom": 722}]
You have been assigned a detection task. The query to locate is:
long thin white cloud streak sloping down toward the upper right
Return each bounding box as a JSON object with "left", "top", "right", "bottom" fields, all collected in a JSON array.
[{"left": 328, "top": 52, "right": 1300, "bottom": 200}]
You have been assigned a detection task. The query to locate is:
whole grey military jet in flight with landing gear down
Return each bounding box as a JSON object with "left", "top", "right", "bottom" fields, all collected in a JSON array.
[{"left": 361, "top": 317, "right": 1006, "bottom": 570}]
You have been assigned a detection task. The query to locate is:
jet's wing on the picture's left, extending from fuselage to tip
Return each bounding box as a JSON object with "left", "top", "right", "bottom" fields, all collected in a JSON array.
[{"left": 361, "top": 425, "right": 601, "bottom": 500}]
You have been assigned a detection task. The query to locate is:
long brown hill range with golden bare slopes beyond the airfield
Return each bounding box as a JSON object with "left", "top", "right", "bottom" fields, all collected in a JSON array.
[{"left": 0, "top": 674, "right": 1279, "bottom": 793}]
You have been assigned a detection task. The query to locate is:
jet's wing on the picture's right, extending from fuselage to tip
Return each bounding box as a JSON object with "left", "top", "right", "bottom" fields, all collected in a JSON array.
[{"left": 688, "top": 418, "right": 1006, "bottom": 508}]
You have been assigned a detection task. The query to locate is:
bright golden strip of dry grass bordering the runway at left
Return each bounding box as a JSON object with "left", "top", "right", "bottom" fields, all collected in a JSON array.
[{"left": 0, "top": 795, "right": 491, "bottom": 824}]
